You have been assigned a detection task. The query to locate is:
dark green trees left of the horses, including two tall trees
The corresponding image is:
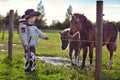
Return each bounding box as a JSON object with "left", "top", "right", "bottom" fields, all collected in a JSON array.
[{"left": 0, "top": 2, "right": 72, "bottom": 30}]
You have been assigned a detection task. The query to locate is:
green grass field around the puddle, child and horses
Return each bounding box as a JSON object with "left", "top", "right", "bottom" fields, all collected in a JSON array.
[{"left": 0, "top": 31, "right": 120, "bottom": 80}]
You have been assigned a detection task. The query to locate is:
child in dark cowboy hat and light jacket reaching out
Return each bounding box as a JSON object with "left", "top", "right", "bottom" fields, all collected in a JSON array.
[{"left": 19, "top": 9, "right": 49, "bottom": 72}]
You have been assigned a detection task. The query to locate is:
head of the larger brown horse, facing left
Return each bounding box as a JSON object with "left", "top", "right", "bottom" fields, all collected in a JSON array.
[{"left": 70, "top": 13, "right": 86, "bottom": 35}]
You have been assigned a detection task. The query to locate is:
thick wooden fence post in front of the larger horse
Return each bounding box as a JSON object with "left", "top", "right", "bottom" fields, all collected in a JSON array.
[{"left": 95, "top": 0, "right": 103, "bottom": 80}]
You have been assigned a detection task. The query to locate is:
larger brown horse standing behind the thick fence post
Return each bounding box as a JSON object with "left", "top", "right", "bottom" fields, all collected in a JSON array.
[{"left": 70, "top": 13, "right": 118, "bottom": 69}]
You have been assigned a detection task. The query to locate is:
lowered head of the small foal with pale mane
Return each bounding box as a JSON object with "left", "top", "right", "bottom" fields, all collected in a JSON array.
[{"left": 60, "top": 28, "right": 70, "bottom": 50}]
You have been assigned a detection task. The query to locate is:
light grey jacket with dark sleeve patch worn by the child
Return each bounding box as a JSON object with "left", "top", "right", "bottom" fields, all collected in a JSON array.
[{"left": 19, "top": 23, "right": 47, "bottom": 47}]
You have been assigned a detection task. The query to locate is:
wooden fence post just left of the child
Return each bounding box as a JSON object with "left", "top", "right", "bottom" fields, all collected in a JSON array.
[{"left": 8, "top": 10, "right": 14, "bottom": 59}]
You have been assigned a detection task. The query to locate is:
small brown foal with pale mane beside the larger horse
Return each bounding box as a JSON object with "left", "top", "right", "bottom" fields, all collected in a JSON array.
[{"left": 60, "top": 28, "right": 80, "bottom": 65}]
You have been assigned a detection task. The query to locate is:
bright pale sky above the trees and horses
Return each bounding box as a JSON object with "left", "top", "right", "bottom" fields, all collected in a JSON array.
[{"left": 0, "top": 0, "right": 120, "bottom": 24}]
